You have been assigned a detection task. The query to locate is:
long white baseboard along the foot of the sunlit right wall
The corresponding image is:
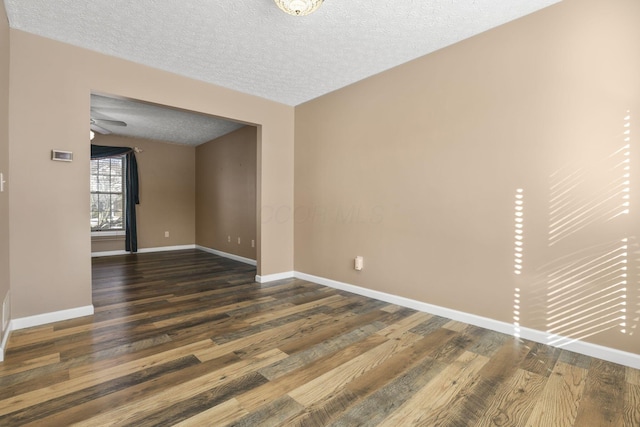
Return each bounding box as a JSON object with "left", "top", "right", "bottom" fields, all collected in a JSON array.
[{"left": 296, "top": 271, "right": 640, "bottom": 369}]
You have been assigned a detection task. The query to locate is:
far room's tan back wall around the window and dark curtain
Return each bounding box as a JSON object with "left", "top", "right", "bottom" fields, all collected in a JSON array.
[{"left": 91, "top": 134, "right": 196, "bottom": 252}]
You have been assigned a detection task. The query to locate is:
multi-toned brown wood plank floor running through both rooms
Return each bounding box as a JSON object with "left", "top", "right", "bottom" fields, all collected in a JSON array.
[{"left": 0, "top": 250, "right": 640, "bottom": 427}]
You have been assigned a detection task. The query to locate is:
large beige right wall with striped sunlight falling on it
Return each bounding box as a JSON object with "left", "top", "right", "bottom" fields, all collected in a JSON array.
[{"left": 295, "top": 0, "right": 640, "bottom": 353}]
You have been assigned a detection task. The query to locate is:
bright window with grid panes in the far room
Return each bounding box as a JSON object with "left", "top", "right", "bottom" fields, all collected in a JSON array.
[{"left": 91, "top": 156, "right": 125, "bottom": 231}]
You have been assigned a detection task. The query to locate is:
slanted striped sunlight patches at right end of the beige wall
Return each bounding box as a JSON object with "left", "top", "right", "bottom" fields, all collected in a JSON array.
[{"left": 545, "top": 111, "right": 636, "bottom": 345}]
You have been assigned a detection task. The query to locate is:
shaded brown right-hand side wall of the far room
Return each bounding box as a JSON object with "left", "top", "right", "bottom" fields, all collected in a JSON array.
[{"left": 195, "top": 126, "right": 257, "bottom": 259}]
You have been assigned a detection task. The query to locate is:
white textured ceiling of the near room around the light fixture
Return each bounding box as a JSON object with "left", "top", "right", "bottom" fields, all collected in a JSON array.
[{"left": 4, "top": 0, "right": 560, "bottom": 142}]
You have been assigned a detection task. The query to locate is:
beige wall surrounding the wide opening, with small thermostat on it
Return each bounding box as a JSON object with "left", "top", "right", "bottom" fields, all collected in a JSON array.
[{"left": 9, "top": 30, "right": 294, "bottom": 318}]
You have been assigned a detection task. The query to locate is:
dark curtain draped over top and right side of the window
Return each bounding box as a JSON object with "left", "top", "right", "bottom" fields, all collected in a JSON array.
[{"left": 91, "top": 144, "right": 140, "bottom": 252}]
